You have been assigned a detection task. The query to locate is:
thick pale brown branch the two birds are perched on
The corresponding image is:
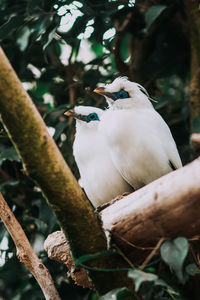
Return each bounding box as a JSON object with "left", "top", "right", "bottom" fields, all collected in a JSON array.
[{"left": 101, "top": 158, "right": 200, "bottom": 263}]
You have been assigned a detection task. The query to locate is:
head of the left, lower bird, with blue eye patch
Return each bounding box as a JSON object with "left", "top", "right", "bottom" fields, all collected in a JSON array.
[{"left": 64, "top": 106, "right": 103, "bottom": 128}]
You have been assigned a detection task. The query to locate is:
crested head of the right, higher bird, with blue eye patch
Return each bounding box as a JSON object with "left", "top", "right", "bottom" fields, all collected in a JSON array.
[{"left": 94, "top": 77, "right": 152, "bottom": 108}]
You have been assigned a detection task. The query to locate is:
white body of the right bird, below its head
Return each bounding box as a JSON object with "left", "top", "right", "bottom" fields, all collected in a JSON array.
[{"left": 100, "top": 109, "right": 182, "bottom": 189}]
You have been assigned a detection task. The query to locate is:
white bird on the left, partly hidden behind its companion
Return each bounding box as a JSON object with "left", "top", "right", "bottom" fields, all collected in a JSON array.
[{"left": 65, "top": 106, "right": 133, "bottom": 207}]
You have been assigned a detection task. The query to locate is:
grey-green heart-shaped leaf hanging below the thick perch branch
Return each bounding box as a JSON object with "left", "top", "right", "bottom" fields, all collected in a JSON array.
[{"left": 160, "top": 237, "right": 189, "bottom": 283}]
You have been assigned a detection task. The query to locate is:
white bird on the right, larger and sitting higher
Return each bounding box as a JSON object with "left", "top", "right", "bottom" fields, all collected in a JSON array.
[{"left": 94, "top": 77, "right": 182, "bottom": 189}]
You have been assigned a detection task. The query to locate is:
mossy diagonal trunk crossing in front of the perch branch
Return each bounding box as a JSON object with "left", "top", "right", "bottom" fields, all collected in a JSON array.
[{"left": 0, "top": 49, "right": 131, "bottom": 294}]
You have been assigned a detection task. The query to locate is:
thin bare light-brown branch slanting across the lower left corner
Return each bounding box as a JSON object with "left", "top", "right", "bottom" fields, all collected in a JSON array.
[{"left": 0, "top": 193, "right": 60, "bottom": 300}]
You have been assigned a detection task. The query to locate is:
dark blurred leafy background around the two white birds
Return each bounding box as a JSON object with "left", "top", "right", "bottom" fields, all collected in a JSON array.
[{"left": 0, "top": 0, "right": 199, "bottom": 300}]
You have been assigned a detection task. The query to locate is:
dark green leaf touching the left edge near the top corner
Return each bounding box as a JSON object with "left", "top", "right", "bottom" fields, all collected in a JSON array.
[{"left": 0, "top": 16, "right": 24, "bottom": 40}]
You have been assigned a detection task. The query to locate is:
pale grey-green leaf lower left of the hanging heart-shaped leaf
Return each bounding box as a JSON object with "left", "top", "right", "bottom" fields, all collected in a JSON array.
[{"left": 128, "top": 270, "right": 158, "bottom": 292}]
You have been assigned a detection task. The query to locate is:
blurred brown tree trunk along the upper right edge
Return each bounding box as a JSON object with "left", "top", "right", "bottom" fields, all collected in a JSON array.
[{"left": 184, "top": 0, "right": 200, "bottom": 122}]
